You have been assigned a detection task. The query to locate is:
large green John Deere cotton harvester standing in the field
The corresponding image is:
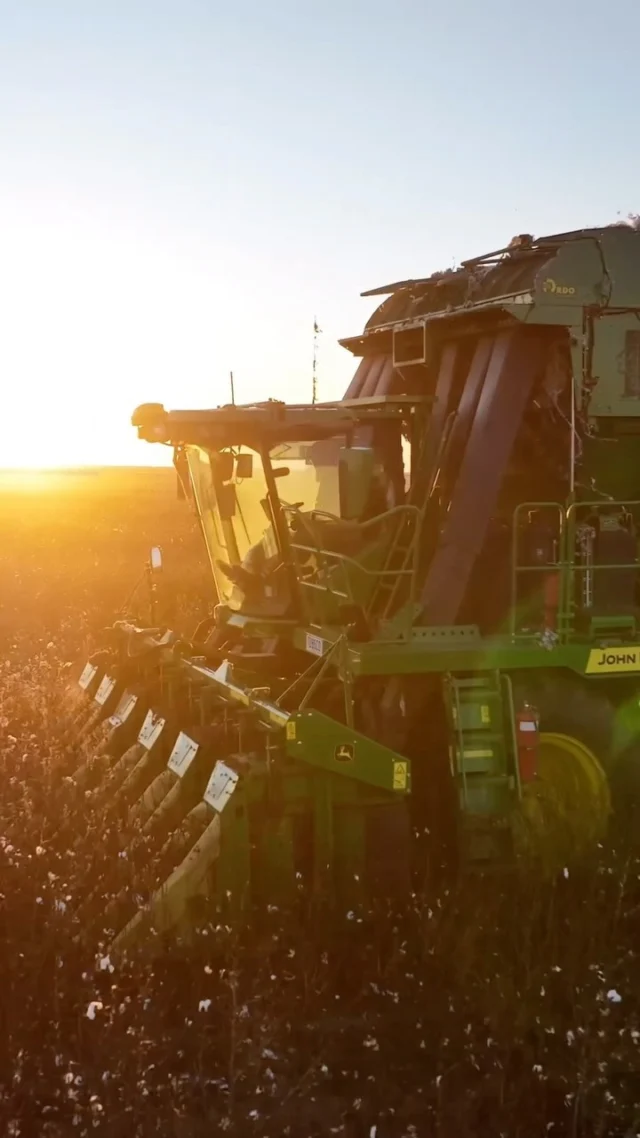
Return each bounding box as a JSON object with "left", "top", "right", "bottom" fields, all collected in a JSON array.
[{"left": 68, "top": 225, "right": 640, "bottom": 949}]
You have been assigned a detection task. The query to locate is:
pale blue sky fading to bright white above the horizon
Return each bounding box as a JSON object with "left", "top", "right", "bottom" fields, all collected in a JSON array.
[{"left": 0, "top": 0, "right": 640, "bottom": 468}]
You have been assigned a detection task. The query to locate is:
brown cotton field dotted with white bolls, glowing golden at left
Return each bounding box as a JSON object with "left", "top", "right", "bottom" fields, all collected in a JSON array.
[{"left": 0, "top": 470, "right": 640, "bottom": 1138}]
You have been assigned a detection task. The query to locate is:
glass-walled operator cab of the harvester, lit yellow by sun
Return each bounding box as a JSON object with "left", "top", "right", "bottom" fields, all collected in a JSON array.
[{"left": 186, "top": 409, "right": 414, "bottom": 622}]
